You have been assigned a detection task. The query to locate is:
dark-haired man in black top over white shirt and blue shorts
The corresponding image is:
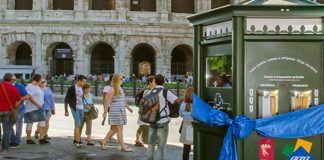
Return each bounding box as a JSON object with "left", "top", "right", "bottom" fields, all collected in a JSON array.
[{"left": 64, "top": 75, "right": 86, "bottom": 147}]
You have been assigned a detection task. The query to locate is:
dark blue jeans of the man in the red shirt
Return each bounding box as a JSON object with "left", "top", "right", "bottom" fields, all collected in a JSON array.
[{"left": 0, "top": 112, "right": 13, "bottom": 150}]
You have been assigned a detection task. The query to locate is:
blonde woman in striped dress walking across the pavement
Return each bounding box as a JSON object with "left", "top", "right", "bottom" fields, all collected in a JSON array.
[{"left": 100, "top": 74, "right": 133, "bottom": 152}]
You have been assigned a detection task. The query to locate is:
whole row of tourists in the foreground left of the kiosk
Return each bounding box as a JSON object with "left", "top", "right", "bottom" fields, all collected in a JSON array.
[{"left": 0, "top": 73, "right": 193, "bottom": 160}]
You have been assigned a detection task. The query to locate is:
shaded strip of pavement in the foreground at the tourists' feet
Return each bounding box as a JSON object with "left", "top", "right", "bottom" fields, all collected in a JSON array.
[{"left": 0, "top": 137, "right": 190, "bottom": 160}]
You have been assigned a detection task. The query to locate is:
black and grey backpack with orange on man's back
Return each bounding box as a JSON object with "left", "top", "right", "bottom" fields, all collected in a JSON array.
[{"left": 138, "top": 88, "right": 163, "bottom": 124}]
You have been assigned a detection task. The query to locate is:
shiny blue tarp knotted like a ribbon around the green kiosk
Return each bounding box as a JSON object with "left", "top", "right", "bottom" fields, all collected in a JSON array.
[{"left": 192, "top": 94, "right": 324, "bottom": 160}]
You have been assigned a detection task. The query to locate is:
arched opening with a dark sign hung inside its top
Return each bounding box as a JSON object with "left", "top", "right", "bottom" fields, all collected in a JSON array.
[{"left": 48, "top": 42, "right": 74, "bottom": 76}]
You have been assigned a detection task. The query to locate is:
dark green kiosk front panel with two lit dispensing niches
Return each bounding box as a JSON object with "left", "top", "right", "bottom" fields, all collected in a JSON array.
[{"left": 244, "top": 41, "right": 323, "bottom": 160}]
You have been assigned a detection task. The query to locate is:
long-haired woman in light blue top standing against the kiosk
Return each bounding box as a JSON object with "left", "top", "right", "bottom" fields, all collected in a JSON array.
[{"left": 179, "top": 87, "right": 193, "bottom": 160}]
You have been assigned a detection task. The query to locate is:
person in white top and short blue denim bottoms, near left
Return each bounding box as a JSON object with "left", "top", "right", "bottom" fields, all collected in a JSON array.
[{"left": 24, "top": 74, "right": 49, "bottom": 144}]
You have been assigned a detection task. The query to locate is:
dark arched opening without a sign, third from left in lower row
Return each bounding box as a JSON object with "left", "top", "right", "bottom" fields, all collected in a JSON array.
[{"left": 90, "top": 43, "right": 115, "bottom": 74}]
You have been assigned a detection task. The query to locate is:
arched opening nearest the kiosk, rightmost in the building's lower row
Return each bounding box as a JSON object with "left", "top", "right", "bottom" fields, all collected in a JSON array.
[{"left": 171, "top": 45, "right": 192, "bottom": 80}]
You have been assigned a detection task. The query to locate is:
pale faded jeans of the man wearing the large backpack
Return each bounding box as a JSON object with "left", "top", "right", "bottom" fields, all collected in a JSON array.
[{"left": 147, "top": 123, "right": 169, "bottom": 160}]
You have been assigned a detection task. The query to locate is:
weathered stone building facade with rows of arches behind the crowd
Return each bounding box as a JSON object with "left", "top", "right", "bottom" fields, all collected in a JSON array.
[{"left": 0, "top": 0, "right": 322, "bottom": 77}]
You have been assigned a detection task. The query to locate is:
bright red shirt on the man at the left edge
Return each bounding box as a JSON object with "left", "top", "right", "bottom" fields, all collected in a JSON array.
[{"left": 0, "top": 81, "right": 21, "bottom": 112}]
